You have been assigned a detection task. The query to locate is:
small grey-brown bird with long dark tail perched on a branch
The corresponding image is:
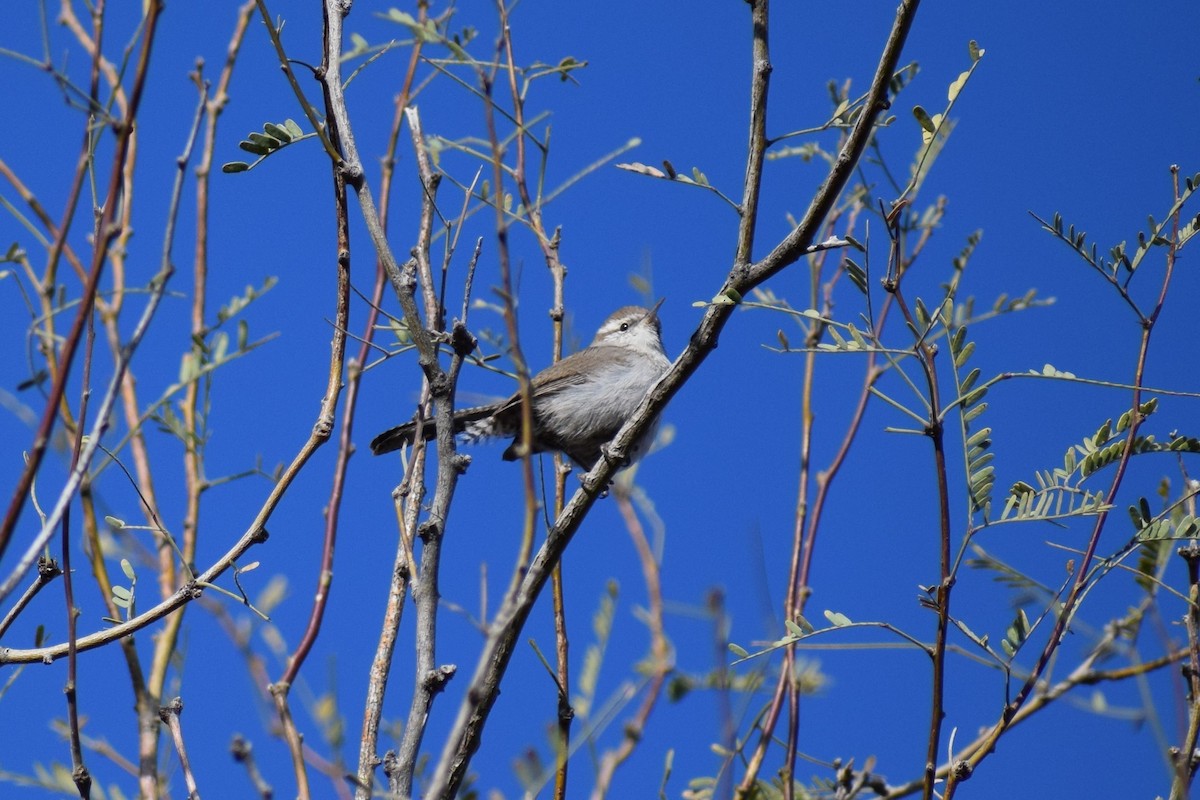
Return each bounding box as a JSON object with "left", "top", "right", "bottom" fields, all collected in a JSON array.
[{"left": 371, "top": 300, "right": 671, "bottom": 471}]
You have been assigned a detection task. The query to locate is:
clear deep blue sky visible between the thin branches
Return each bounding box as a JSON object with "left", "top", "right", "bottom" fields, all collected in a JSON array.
[{"left": 0, "top": 0, "right": 1200, "bottom": 798}]
